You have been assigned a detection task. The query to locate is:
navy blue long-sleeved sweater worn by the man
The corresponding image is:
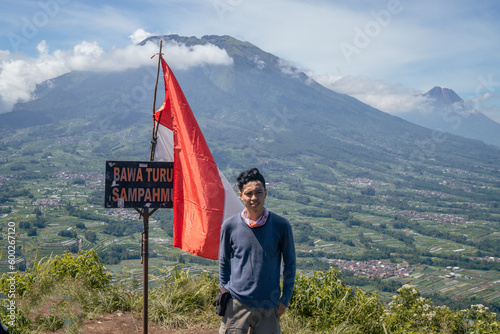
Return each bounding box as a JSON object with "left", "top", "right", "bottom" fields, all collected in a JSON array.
[{"left": 219, "top": 212, "right": 296, "bottom": 307}]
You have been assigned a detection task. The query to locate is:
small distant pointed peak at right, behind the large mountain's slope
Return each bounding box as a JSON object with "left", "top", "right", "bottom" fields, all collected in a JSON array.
[{"left": 401, "top": 86, "right": 500, "bottom": 146}]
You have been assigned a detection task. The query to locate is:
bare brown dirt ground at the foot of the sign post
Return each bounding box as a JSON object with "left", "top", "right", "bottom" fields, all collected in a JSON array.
[{"left": 48, "top": 312, "right": 219, "bottom": 334}]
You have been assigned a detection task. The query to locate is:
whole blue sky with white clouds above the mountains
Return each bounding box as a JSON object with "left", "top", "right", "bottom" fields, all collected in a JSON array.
[{"left": 0, "top": 0, "right": 500, "bottom": 121}]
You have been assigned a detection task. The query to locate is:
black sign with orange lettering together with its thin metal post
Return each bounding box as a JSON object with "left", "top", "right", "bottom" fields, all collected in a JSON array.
[{"left": 104, "top": 161, "right": 174, "bottom": 334}]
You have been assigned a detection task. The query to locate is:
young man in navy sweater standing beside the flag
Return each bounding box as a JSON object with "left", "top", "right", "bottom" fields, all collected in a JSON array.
[{"left": 219, "top": 168, "right": 295, "bottom": 334}]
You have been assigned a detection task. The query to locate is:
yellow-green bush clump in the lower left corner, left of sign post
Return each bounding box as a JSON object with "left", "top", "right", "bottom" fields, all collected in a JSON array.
[{"left": 0, "top": 250, "right": 114, "bottom": 333}]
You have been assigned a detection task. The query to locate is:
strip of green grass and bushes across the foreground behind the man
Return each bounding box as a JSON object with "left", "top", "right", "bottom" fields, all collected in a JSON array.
[{"left": 0, "top": 251, "right": 500, "bottom": 334}]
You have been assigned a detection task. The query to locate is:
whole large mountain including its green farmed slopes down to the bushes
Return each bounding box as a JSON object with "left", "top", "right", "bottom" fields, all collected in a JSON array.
[{"left": 0, "top": 36, "right": 500, "bottom": 318}]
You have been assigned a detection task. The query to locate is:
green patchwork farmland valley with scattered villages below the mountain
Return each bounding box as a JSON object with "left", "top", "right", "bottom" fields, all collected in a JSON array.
[{"left": 0, "top": 114, "right": 500, "bottom": 308}]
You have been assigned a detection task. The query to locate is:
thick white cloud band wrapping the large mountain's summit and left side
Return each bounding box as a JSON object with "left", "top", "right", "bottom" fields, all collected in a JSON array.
[{"left": 0, "top": 29, "right": 232, "bottom": 113}]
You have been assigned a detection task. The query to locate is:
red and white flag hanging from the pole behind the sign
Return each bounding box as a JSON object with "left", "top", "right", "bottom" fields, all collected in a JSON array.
[{"left": 154, "top": 58, "right": 244, "bottom": 260}]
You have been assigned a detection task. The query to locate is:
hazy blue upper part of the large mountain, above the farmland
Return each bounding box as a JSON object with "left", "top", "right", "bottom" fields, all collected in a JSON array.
[{"left": 4, "top": 35, "right": 498, "bottom": 169}]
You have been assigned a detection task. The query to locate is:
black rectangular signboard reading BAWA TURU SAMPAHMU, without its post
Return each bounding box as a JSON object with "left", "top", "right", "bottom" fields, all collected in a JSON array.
[{"left": 104, "top": 161, "right": 174, "bottom": 208}]
